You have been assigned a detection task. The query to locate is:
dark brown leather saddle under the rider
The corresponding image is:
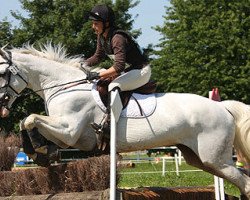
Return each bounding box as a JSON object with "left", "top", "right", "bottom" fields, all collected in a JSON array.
[{"left": 96, "top": 80, "right": 157, "bottom": 109}]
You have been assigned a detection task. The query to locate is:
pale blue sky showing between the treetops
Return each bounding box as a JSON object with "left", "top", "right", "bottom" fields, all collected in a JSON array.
[{"left": 0, "top": 0, "right": 170, "bottom": 47}]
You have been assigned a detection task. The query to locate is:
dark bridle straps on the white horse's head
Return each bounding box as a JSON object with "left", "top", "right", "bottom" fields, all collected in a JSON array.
[{"left": 0, "top": 51, "right": 28, "bottom": 109}]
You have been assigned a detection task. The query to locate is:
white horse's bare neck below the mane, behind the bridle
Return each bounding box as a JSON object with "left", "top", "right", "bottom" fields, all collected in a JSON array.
[{"left": 13, "top": 54, "right": 84, "bottom": 98}]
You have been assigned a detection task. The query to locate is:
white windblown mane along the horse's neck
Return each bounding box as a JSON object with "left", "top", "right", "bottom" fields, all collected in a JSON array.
[{"left": 12, "top": 43, "right": 83, "bottom": 67}]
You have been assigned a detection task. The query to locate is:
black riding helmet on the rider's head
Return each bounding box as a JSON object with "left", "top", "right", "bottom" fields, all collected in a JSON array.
[{"left": 89, "top": 5, "right": 115, "bottom": 26}]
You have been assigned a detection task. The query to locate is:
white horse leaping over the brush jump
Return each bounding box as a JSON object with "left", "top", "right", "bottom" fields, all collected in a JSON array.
[{"left": 0, "top": 45, "right": 250, "bottom": 198}]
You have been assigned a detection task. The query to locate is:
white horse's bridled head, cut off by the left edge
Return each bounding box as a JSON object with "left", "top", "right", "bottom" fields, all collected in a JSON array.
[{"left": 0, "top": 48, "right": 27, "bottom": 117}]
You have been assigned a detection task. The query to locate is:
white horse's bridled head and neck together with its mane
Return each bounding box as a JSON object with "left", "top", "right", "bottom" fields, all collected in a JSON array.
[{"left": 0, "top": 43, "right": 91, "bottom": 117}]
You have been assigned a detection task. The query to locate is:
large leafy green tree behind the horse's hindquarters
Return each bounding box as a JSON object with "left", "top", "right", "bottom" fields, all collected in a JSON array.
[{"left": 152, "top": 0, "right": 250, "bottom": 104}]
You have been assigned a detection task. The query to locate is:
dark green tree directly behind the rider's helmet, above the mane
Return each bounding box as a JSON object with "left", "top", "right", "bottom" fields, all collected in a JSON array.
[{"left": 13, "top": 0, "right": 140, "bottom": 57}]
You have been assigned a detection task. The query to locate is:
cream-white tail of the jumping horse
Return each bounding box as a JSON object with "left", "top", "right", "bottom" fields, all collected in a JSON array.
[{"left": 222, "top": 101, "right": 250, "bottom": 163}]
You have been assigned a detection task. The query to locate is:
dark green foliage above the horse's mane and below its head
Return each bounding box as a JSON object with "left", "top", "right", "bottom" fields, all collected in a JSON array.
[{"left": 0, "top": 0, "right": 141, "bottom": 132}]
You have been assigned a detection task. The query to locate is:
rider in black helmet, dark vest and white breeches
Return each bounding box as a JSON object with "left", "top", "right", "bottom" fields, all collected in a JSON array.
[{"left": 84, "top": 5, "right": 151, "bottom": 137}]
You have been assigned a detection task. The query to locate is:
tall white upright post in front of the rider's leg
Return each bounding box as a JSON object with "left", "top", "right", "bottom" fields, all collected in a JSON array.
[{"left": 110, "top": 89, "right": 122, "bottom": 200}]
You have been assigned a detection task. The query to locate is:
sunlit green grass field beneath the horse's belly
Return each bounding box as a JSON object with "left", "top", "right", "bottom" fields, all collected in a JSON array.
[{"left": 118, "top": 152, "right": 240, "bottom": 197}]
